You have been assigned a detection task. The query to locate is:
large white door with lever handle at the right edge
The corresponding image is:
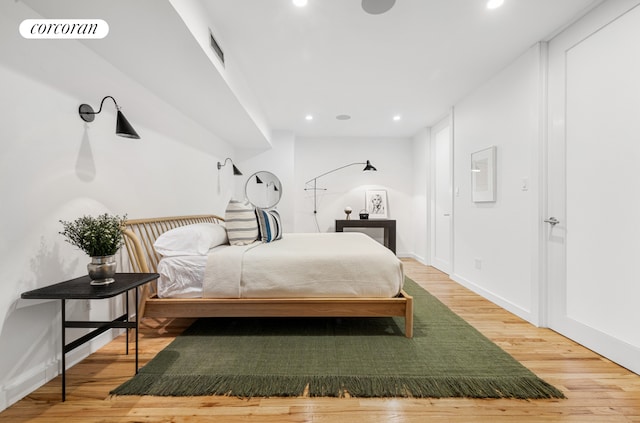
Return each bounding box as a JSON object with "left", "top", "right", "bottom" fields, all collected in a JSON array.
[{"left": 544, "top": 2, "right": 640, "bottom": 372}]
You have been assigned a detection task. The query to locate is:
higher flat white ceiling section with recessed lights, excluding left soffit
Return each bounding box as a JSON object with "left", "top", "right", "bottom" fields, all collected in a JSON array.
[{"left": 200, "top": 0, "right": 599, "bottom": 137}]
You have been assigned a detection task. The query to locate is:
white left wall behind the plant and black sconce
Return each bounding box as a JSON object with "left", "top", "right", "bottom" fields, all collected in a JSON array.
[{"left": 0, "top": 2, "right": 234, "bottom": 410}]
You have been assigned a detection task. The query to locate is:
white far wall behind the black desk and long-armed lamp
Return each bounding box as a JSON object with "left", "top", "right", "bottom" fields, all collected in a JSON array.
[{"left": 291, "top": 138, "right": 414, "bottom": 255}]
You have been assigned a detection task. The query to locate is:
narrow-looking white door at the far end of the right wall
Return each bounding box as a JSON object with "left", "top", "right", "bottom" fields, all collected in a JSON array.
[{"left": 431, "top": 119, "right": 453, "bottom": 274}]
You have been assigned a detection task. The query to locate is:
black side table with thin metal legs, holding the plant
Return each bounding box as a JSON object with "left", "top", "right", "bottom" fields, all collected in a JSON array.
[{"left": 22, "top": 273, "right": 160, "bottom": 401}]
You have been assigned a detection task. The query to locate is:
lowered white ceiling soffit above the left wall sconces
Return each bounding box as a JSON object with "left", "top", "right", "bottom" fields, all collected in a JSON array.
[{"left": 20, "top": 0, "right": 269, "bottom": 150}]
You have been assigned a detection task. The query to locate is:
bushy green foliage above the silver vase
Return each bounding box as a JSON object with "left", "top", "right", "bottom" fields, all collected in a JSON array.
[{"left": 60, "top": 213, "right": 127, "bottom": 257}]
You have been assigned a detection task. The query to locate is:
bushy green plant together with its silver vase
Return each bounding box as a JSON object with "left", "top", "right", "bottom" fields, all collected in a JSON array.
[{"left": 60, "top": 213, "right": 127, "bottom": 285}]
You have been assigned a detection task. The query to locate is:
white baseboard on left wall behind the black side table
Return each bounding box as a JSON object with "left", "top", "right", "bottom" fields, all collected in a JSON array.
[{"left": 0, "top": 329, "right": 124, "bottom": 412}]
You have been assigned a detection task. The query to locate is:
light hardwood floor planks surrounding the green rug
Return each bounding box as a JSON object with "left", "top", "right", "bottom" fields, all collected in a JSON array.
[{"left": 0, "top": 260, "right": 640, "bottom": 423}]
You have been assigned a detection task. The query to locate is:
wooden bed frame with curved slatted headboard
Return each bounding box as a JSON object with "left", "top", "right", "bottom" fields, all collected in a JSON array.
[{"left": 124, "top": 215, "right": 413, "bottom": 338}]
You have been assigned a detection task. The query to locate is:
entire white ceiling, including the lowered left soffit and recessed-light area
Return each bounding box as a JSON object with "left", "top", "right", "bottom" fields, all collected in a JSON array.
[{"left": 22, "top": 0, "right": 602, "bottom": 146}]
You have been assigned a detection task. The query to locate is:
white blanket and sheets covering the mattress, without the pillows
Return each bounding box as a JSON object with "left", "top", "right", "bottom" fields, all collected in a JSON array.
[{"left": 158, "top": 232, "right": 404, "bottom": 298}]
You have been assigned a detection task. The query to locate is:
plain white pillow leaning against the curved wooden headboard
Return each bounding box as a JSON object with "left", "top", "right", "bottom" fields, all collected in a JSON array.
[{"left": 153, "top": 223, "right": 229, "bottom": 256}]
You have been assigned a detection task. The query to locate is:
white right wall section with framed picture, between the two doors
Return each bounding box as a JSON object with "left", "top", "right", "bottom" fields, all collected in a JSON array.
[{"left": 451, "top": 46, "right": 541, "bottom": 323}]
